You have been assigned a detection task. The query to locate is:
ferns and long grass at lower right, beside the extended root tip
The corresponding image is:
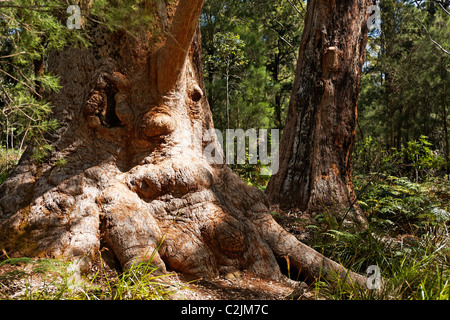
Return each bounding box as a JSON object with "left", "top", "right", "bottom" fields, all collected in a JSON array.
[{"left": 309, "top": 177, "right": 450, "bottom": 300}]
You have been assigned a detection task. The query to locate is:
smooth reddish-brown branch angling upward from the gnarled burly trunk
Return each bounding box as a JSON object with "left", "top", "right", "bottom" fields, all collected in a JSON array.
[{"left": 157, "top": 0, "right": 205, "bottom": 94}]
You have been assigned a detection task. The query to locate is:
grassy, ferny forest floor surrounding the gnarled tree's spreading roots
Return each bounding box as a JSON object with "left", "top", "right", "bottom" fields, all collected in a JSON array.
[{"left": 0, "top": 180, "right": 450, "bottom": 300}]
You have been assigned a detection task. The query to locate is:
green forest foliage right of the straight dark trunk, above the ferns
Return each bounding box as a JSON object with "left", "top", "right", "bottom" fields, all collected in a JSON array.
[{"left": 355, "top": 0, "right": 450, "bottom": 175}]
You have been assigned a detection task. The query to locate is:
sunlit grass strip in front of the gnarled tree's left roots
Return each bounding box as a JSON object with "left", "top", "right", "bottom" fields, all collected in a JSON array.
[{"left": 0, "top": 257, "right": 182, "bottom": 300}]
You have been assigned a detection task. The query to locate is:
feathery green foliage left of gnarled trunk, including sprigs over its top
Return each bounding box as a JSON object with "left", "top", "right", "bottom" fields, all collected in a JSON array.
[{"left": 0, "top": 0, "right": 160, "bottom": 172}]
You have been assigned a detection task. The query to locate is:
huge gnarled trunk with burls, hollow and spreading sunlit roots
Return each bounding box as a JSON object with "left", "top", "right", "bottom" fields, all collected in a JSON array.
[{"left": 0, "top": 0, "right": 365, "bottom": 285}]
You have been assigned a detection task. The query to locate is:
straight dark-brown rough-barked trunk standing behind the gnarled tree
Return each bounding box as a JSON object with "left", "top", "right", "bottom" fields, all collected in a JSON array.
[{"left": 267, "top": 0, "right": 369, "bottom": 225}]
